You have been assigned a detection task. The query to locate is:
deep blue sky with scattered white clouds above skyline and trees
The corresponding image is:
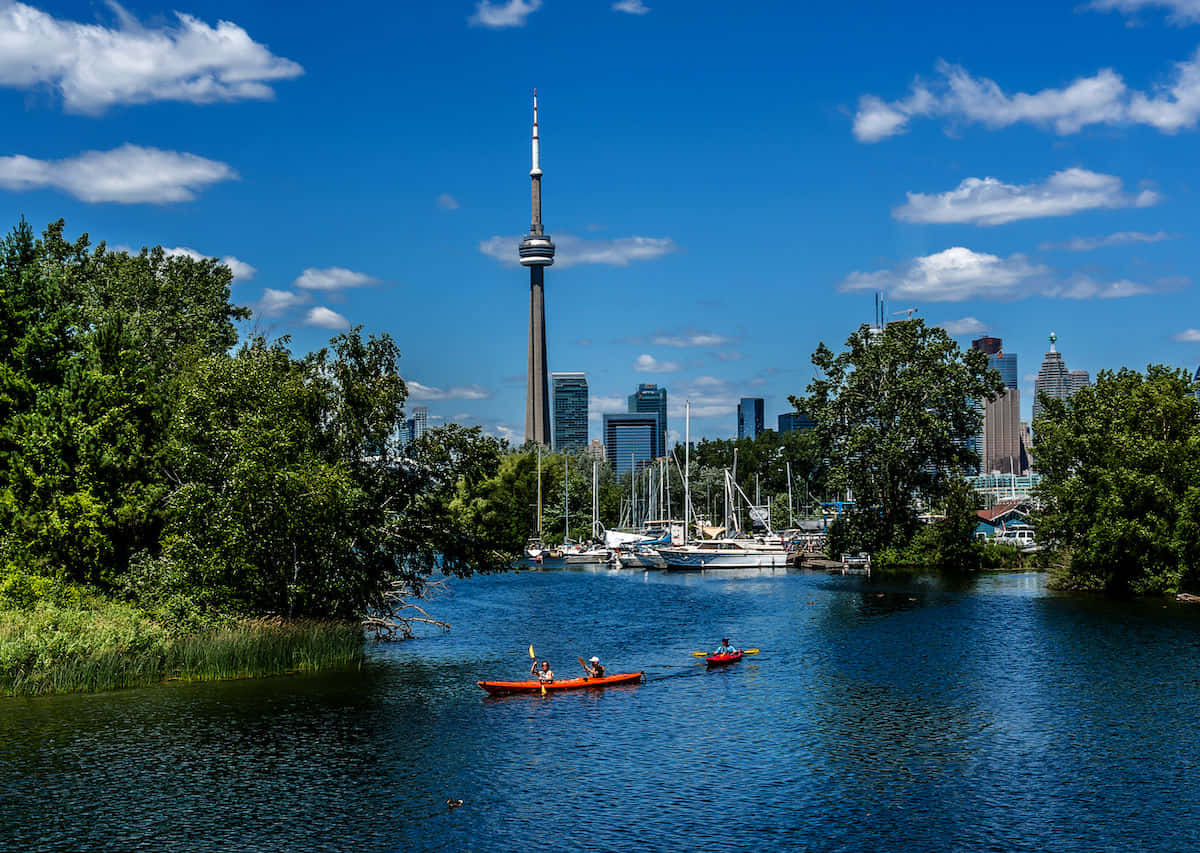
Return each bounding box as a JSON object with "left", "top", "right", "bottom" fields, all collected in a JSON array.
[{"left": 0, "top": 0, "right": 1200, "bottom": 439}]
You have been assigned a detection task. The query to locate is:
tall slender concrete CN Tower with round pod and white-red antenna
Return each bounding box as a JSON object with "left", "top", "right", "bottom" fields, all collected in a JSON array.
[{"left": 518, "top": 89, "right": 554, "bottom": 445}]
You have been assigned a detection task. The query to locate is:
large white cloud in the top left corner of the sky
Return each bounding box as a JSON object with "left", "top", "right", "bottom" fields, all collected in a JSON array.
[{"left": 0, "top": 0, "right": 304, "bottom": 115}]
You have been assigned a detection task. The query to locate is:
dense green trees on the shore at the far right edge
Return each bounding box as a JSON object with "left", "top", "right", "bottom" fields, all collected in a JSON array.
[{"left": 1033, "top": 365, "right": 1200, "bottom": 594}]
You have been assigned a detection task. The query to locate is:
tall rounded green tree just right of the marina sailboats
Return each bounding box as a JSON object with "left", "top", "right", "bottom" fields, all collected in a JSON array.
[{"left": 791, "top": 319, "right": 1002, "bottom": 552}]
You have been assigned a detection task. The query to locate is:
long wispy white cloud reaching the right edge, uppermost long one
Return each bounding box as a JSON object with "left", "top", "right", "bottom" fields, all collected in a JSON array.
[{"left": 853, "top": 49, "right": 1200, "bottom": 143}]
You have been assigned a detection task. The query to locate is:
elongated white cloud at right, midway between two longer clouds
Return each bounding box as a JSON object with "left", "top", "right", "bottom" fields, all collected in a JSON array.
[{"left": 892, "top": 168, "right": 1162, "bottom": 226}]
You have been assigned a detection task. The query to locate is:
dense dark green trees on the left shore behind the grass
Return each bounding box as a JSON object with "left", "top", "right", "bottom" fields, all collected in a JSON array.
[{"left": 0, "top": 221, "right": 526, "bottom": 621}]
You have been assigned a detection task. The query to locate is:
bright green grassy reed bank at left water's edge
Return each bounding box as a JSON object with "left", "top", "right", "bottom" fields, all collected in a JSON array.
[{"left": 0, "top": 600, "right": 362, "bottom": 696}]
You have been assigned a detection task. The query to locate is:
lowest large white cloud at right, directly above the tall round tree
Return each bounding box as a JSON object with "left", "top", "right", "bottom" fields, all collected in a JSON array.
[{"left": 838, "top": 246, "right": 1156, "bottom": 302}]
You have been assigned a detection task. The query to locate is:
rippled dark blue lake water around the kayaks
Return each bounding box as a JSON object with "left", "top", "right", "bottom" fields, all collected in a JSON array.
[{"left": 0, "top": 571, "right": 1200, "bottom": 853}]
